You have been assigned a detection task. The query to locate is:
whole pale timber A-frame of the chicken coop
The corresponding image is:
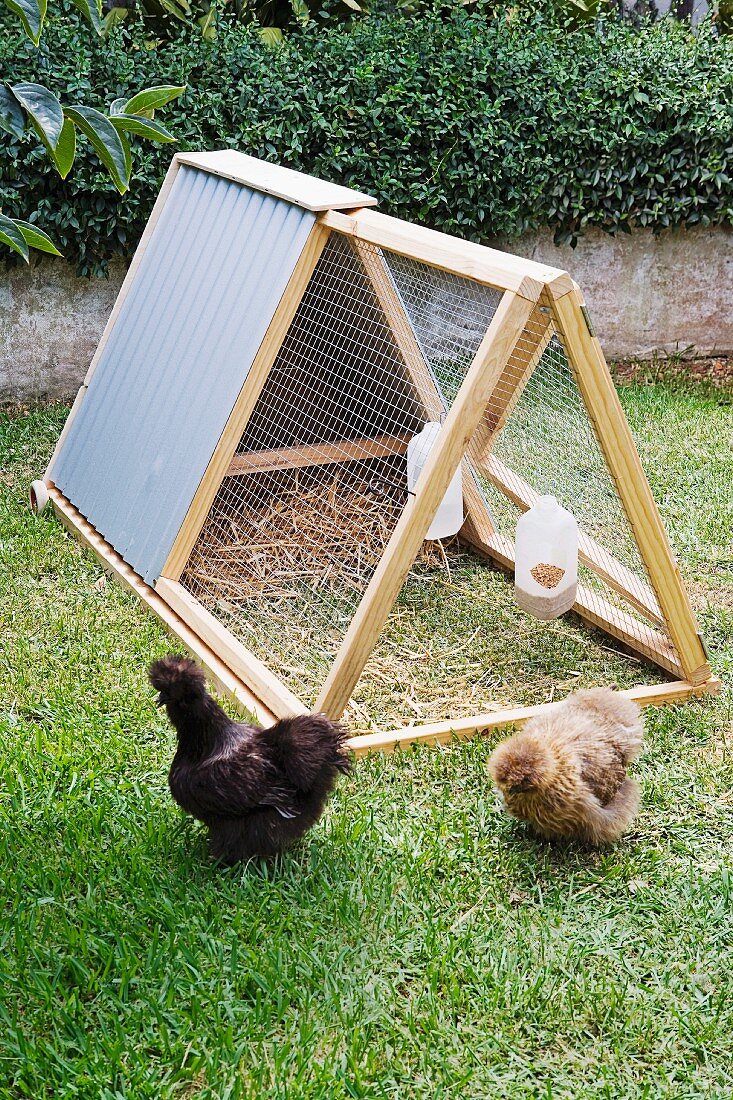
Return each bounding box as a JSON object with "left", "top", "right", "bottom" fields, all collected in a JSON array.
[{"left": 46, "top": 151, "right": 720, "bottom": 754}]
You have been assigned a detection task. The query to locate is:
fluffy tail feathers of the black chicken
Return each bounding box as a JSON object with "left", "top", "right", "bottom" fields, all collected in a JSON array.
[{"left": 262, "top": 714, "right": 352, "bottom": 791}]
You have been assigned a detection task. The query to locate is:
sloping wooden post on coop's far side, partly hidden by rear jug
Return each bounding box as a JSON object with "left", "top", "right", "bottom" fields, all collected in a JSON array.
[{"left": 354, "top": 249, "right": 494, "bottom": 540}]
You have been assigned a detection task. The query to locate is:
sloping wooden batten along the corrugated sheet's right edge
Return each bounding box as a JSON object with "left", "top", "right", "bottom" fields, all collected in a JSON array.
[{"left": 162, "top": 223, "right": 329, "bottom": 581}]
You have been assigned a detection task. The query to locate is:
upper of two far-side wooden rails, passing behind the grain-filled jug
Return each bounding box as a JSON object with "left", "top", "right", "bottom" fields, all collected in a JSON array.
[{"left": 477, "top": 454, "right": 665, "bottom": 626}]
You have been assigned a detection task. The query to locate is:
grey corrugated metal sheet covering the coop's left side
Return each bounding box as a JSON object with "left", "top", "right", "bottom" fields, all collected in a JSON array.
[{"left": 51, "top": 167, "right": 316, "bottom": 582}]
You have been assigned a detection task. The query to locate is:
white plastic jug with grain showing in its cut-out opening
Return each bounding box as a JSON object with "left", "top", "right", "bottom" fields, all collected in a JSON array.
[{"left": 514, "top": 496, "right": 578, "bottom": 619}]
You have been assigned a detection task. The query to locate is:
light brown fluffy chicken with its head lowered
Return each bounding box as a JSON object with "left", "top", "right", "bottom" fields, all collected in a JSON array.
[{"left": 489, "top": 688, "right": 644, "bottom": 845}]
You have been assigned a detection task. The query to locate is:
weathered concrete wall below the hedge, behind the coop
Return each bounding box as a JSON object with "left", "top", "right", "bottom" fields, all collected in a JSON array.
[{"left": 0, "top": 229, "right": 733, "bottom": 402}]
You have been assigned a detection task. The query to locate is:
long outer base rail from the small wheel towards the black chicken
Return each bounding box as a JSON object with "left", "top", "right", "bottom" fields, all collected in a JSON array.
[{"left": 48, "top": 485, "right": 275, "bottom": 726}]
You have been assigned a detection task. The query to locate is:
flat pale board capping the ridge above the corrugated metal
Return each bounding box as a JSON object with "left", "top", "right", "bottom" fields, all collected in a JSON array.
[{"left": 173, "top": 149, "right": 378, "bottom": 211}]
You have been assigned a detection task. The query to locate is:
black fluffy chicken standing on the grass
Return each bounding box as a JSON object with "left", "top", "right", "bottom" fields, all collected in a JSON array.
[{"left": 149, "top": 653, "right": 351, "bottom": 864}]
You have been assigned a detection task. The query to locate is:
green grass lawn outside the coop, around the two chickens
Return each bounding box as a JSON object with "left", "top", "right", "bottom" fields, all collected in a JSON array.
[{"left": 0, "top": 383, "right": 733, "bottom": 1100}]
